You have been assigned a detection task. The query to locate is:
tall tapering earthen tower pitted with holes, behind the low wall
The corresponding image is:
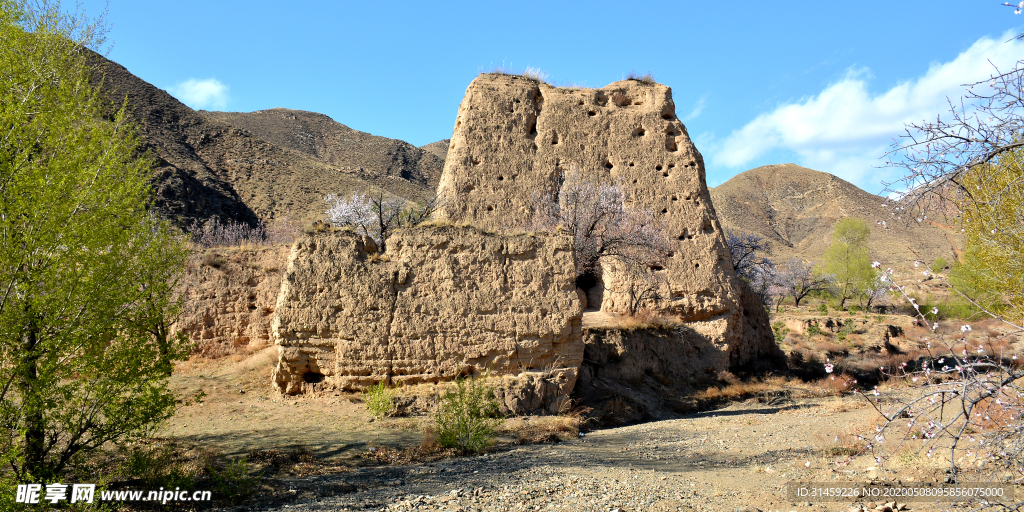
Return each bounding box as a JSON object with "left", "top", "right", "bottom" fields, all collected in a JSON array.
[{"left": 438, "top": 75, "right": 763, "bottom": 364}]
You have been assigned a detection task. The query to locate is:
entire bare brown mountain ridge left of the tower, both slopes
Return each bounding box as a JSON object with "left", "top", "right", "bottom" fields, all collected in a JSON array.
[{"left": 94, "top": 55, "right": 442, "bottom": 224}]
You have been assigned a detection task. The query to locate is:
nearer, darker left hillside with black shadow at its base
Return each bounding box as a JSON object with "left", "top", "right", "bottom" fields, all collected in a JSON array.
[{"left": 94, "top": 55, "right": 441, "bottom": 224}]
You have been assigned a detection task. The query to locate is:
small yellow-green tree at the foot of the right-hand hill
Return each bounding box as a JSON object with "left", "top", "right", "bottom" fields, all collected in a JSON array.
[{"left": 824, "top": 217, "right": 877, "bottom": 308}]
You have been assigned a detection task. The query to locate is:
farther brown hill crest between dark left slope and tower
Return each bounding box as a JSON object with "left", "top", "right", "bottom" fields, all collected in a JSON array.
[{"left": 199, "top": 109, "right": 444, "bottom": 189}]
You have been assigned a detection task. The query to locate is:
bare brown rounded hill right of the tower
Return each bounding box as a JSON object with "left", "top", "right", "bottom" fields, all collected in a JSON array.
[{"left": 711, "top": 164, "right": 961, "bottom": 266}]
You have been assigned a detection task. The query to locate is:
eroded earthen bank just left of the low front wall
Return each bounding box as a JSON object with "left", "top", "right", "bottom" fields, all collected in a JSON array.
[{"left": 174, "top": 246, "right": 291, "bottom": 357}]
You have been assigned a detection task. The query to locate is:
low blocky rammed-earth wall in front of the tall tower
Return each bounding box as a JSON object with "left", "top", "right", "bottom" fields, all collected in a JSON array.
[{"left": 273, "top": 227, "right": 583, "bottom": 412}]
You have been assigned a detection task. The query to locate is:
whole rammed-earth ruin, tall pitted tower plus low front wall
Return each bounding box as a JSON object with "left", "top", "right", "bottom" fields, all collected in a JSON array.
[{"left": 256, "top": 74, "right": 777, "bottom": 412}]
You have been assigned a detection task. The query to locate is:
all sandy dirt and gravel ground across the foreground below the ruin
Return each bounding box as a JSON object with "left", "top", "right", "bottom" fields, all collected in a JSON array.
[{"left": 159, "top": 347, "right": 1024, "bottom": 512}]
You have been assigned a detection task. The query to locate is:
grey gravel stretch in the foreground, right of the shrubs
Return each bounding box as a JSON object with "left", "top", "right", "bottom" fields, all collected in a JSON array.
[{"left": 224, "top": 400, "right": 905, "bottom": 512}]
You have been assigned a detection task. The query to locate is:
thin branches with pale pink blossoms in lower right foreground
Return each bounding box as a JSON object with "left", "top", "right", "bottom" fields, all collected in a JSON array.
[{"left": 825, "top": 264, "right": 1024, "bottom": 510}]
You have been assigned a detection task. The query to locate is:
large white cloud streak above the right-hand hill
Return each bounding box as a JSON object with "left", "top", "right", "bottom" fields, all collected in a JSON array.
[{"left": 713, "top": 32, "right": 1024, "bottom": 191}]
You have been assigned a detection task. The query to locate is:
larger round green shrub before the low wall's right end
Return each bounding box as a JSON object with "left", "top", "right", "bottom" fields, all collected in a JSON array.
[{"left": 434, "top": 377, "right": 501, "bottom": 453}]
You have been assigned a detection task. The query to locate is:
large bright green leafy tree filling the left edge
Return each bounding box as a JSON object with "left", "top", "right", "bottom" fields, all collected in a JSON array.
[{"left": 0, "top": 0, "right": 187, "bottom": 481}]
